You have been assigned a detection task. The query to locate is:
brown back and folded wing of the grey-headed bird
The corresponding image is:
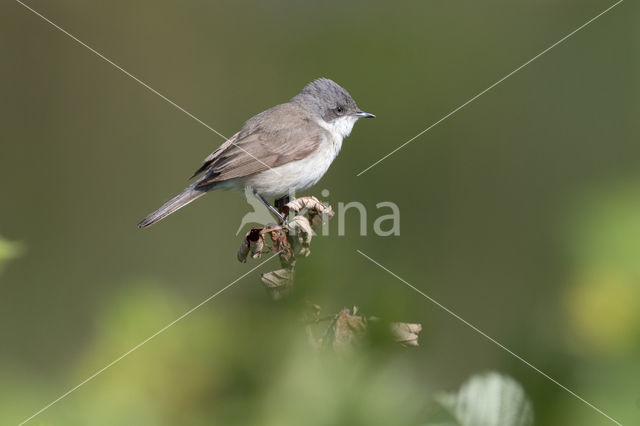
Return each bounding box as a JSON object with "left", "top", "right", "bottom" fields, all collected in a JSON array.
[{"left": 196, "top": 104, "right": 328, "bottom": 187}]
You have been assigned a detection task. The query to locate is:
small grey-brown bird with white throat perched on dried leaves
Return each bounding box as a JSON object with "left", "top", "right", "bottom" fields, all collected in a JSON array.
[{"left": 138, "top": 78, "right": 375, "bottom": 228}]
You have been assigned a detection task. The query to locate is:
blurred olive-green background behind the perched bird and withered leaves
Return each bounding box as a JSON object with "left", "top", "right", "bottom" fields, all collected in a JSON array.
[{"left": 0, "top": 0, "right": 640, "bottom": 425}]
